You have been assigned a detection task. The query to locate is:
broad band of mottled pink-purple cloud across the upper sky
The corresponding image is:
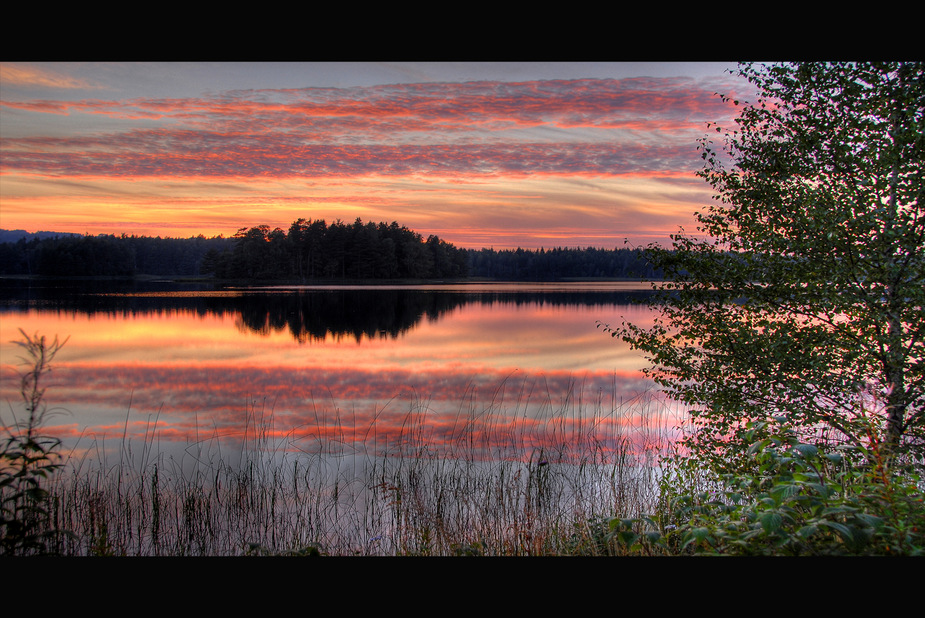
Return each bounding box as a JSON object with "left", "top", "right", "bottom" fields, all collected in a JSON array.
[{"left": 3, "top": 80, "right": 729, "bottom": 177}]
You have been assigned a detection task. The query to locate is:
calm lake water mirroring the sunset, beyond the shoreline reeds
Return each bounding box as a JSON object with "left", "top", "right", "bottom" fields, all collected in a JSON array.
[{"left": 0, "top": 281, "right": 668, "bottom": 462}]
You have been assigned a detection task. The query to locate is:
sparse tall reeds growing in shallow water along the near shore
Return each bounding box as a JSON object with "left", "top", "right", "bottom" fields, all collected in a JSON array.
[{"left": 34, "top": 385, "right": 670, "bottom": 556}]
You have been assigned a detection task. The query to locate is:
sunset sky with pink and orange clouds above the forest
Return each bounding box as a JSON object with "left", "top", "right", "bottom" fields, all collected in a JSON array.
[{"left": 0, "top": 62, "right": 748, "bottom": 249}]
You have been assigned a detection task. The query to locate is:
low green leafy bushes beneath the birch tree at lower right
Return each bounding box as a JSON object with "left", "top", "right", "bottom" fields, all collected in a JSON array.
[{"left": 648, "top": 423, "right": 925, "bottom": 556}]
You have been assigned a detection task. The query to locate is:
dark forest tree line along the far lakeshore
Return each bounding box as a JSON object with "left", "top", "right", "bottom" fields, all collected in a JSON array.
[{"left": 0, "top": 218, "right": 659, "bottom": 282}]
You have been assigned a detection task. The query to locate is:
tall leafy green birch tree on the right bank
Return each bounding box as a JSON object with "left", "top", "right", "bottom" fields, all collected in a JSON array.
[{"left": 606, "top": 63, "right": 925, "bottom": 472}]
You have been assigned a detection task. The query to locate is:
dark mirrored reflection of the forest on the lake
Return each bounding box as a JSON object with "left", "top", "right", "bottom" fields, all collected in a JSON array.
[{"left": 0, "top": 281, "right": 645, "bottom": 342}]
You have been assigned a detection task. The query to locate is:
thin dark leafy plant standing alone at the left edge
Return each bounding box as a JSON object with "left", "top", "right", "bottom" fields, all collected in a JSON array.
[{"left": 0, "top": 330, "right": 67, "bottom": 555}]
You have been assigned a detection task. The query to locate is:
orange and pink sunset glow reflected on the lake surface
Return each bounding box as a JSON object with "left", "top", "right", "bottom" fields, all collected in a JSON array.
[{"left": 0, "top": 284, "right": 664, "bottom": 458}]
